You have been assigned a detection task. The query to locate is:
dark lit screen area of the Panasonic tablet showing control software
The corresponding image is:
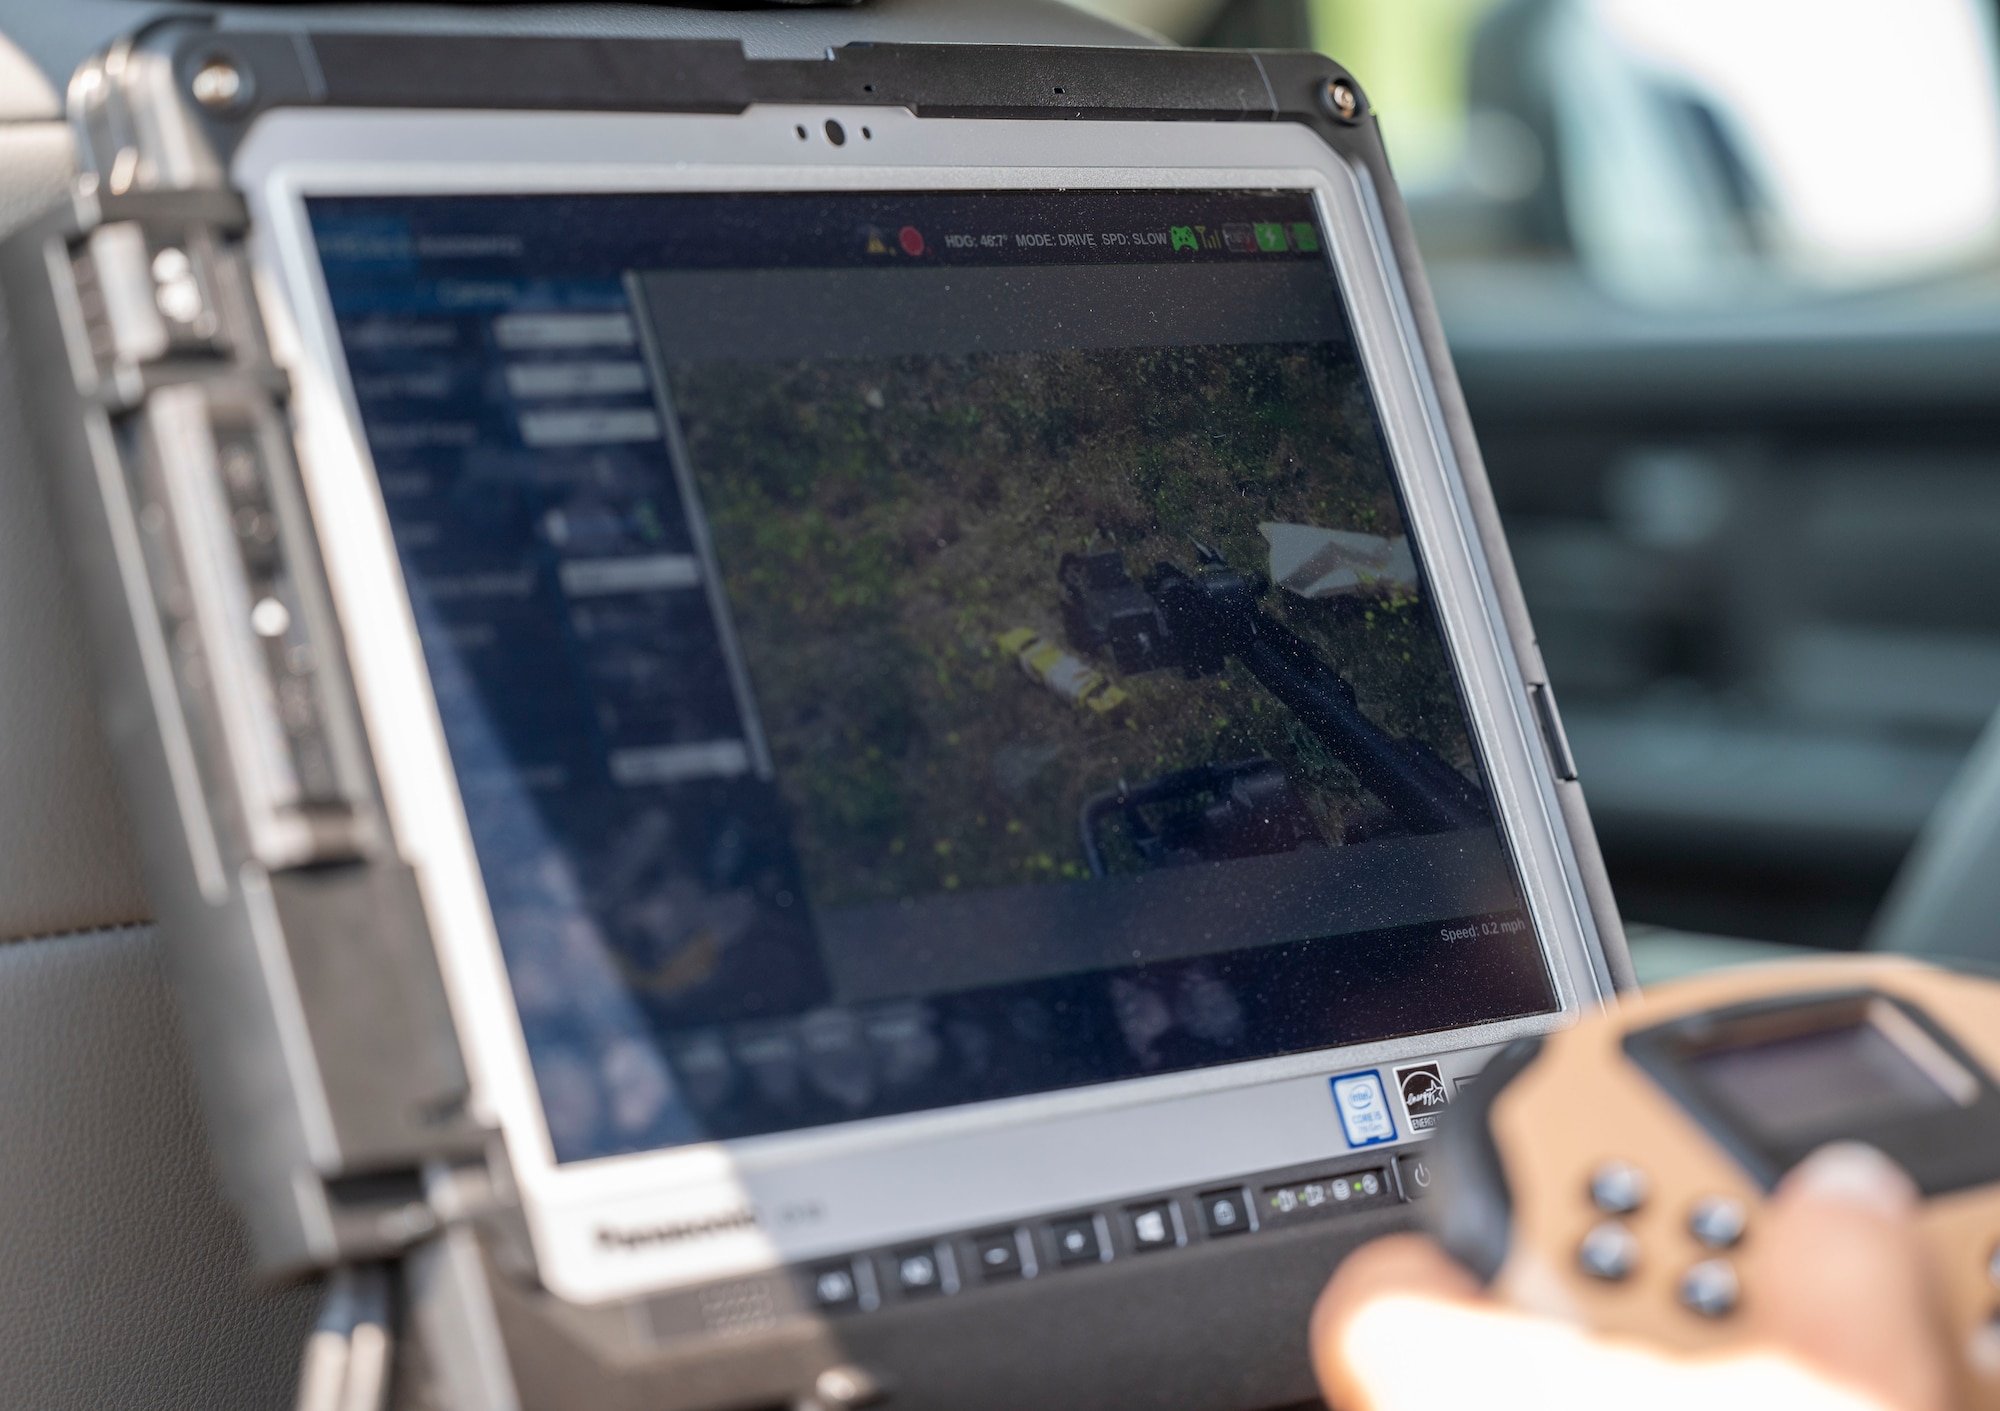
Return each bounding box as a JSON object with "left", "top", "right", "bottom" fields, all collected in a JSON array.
[{"left": 310, "top": 192, "right": 1556, "bottom": 1161}]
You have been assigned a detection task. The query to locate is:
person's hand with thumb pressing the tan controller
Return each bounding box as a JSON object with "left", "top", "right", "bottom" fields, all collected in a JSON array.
[{"left": 1312, "top": 1143, "right": 1952, "bottom": 1411}]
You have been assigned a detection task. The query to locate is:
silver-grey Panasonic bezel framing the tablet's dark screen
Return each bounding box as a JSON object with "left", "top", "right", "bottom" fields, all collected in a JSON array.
[{"left": 232, "top": 104, "right": 1612, "bottom": 1301}]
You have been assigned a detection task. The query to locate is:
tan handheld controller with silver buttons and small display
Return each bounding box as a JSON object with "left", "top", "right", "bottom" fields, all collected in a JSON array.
[{"left": 1432, "top": 957, "right": 2000, "bottom": 1407}]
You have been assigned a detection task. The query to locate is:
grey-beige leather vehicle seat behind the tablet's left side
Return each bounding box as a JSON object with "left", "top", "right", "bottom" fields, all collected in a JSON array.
[{"left": 0, "top": 0, "right": 1152, "bottom": 1411}]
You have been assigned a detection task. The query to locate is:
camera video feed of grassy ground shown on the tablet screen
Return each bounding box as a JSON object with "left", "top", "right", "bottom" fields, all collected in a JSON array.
[{"left": 666, "top": 346, "right": 1488, "bottom": 907}]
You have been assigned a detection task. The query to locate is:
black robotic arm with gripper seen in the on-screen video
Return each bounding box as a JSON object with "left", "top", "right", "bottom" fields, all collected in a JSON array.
[{"left": 1058, "top": 546, "right": 1488, "bottom": 833}]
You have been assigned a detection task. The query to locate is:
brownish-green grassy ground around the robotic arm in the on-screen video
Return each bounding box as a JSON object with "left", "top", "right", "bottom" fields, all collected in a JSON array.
[{"left": 668, "top": 346, "right": 1472, "bottom": 907}]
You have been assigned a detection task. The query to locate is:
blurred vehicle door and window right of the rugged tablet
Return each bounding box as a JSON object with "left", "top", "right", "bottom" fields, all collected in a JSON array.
[{"left": 1102, "top": 0, "right": 2000, "bottom": 973}]
